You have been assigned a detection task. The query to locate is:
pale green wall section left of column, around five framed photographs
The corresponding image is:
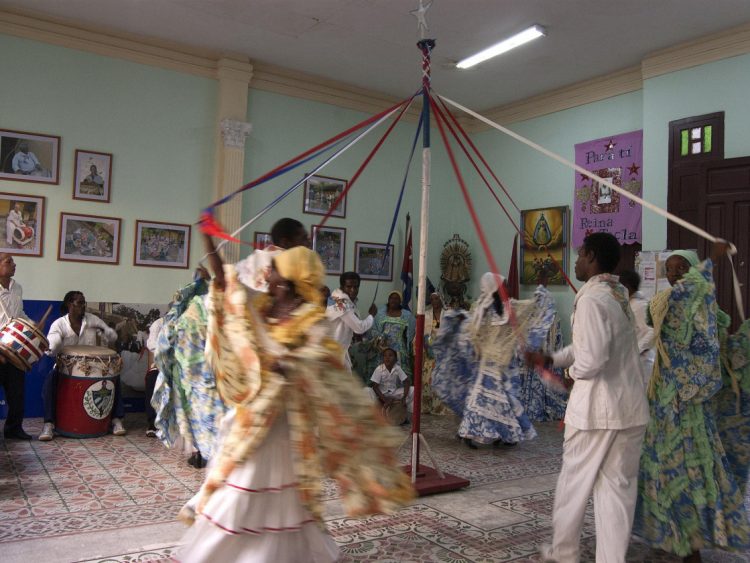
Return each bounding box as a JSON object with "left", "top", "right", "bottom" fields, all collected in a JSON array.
[{"left": 0, "top": 35, "right": 217, "bottom": 303}]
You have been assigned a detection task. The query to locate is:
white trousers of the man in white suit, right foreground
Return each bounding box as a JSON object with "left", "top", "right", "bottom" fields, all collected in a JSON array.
[{"left": 549, "top": 425, "right": 646, "bottom": 563}]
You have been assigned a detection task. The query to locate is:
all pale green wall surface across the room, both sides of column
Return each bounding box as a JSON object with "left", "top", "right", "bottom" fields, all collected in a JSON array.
[{"left": 5, "top": 28, "right": 750, "bottom": 340}]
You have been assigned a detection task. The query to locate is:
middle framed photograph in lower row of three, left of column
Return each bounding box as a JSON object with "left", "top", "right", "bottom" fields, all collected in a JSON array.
[{"left": 57, "top": 211, "right": 121, "bottom": 264}]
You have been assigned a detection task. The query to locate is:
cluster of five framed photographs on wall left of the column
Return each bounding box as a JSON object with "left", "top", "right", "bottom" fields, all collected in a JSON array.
[{"left": 0, "top": 128, "right": 191, "bottom": 269}]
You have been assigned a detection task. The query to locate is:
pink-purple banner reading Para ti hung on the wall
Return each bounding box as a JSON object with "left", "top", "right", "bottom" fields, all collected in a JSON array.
[{"left": 573, "top": 131, "right": 643, "bottom": 248}]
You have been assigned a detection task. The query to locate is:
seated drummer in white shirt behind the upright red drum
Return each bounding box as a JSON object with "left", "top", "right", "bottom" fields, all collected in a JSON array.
[{"left": 39, "top": 291, "right": 126, "bottom": 442}]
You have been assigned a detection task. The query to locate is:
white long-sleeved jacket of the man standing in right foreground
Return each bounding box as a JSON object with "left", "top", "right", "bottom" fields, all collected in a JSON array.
[{"left": 553, "top": 276, "right": 649, "bottom": 430}]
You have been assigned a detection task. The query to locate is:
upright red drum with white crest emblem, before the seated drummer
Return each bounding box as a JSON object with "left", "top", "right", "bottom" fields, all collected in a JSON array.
[{"left": 55, "top": 346, "right": 122, "bottom": 438}]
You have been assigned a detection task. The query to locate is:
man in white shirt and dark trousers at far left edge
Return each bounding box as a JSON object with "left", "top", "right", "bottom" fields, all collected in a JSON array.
[{"left": 0, "top": 252, "right": 31, "bottom": 440}]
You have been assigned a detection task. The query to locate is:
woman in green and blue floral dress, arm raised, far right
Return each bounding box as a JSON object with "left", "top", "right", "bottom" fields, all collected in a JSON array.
[{"left": 633, "top": 243, "right": 750, "bottom": 561}]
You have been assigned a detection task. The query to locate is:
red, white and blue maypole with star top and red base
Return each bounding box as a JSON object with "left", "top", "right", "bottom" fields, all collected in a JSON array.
[{"left": 409, "top": 0, "right": 469, "bottom": 495}]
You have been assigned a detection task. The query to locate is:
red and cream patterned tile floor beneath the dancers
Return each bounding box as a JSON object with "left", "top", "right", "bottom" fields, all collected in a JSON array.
[{"left": 0, "top": 415, "right": 750, "bottom": 563}]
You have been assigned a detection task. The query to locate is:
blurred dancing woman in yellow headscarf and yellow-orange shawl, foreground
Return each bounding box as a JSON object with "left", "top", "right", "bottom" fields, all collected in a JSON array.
[{"left": 178, "top": 238, "right": 413, "bottom": 563}]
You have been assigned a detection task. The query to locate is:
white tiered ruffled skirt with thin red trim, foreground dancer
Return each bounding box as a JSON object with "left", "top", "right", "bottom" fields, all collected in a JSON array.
[{"left": 176, "top": 415, "right": 339, "bottom": 563}]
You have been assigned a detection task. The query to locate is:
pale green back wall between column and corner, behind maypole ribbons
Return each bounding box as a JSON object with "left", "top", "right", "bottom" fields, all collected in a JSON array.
[{"left": 243, "top": 88, "right": 465, "bottom": 314}]
